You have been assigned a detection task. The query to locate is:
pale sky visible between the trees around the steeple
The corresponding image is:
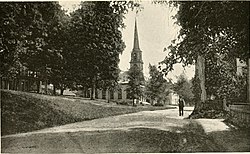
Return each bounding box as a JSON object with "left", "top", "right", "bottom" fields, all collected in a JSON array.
[{"left": 59, "top": 1, "right": 194, "bottom": 82}]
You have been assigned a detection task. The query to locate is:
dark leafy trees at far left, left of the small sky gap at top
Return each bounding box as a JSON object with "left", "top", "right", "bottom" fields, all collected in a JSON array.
[{"left": 0, "top": 2, "right": 67, "bottom": 92}]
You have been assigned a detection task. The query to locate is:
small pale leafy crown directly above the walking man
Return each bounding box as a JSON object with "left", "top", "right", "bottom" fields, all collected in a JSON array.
[{"left": 174, "top": 74, "right": 194, "bottom": 104}]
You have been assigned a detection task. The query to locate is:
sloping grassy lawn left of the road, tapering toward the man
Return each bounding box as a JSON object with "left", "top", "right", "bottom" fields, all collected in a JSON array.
[{"left": 1, "top": 90, "right": 175, "bottom": 135}]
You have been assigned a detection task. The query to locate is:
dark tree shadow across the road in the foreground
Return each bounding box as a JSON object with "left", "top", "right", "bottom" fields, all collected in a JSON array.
[{"left": 2, "top": 121, "right": 238, "bottom": 153}]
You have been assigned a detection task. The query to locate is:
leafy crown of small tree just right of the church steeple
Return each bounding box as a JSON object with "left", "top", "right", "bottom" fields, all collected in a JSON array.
[{"left": 145, "top": 65, "right": 172, "bottom": 102}]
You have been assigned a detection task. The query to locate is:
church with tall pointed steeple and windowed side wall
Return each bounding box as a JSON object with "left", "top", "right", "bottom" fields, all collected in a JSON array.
[{"left": 93, "top": 20, "right": 143, "bottom": 102}]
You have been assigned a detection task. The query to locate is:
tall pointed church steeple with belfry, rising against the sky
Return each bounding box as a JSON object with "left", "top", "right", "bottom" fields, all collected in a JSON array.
[{"left": 130, "top": 19, "right": 143, "bottom": 72}]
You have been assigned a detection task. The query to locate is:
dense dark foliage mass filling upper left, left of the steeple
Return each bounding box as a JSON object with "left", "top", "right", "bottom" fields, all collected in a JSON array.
[{"left": 0, "top": 2, "right": 129, "bottom": 96}]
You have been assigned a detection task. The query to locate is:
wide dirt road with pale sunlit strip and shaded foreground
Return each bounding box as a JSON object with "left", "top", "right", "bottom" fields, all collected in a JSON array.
[{"left": 1, "top": 107, "right": 250, "bottom": 153}]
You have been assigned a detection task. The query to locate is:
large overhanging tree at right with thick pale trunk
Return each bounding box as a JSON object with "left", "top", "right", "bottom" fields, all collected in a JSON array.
[{"left": 163, "top": 1, "right": 249, "bottom": 109}]
